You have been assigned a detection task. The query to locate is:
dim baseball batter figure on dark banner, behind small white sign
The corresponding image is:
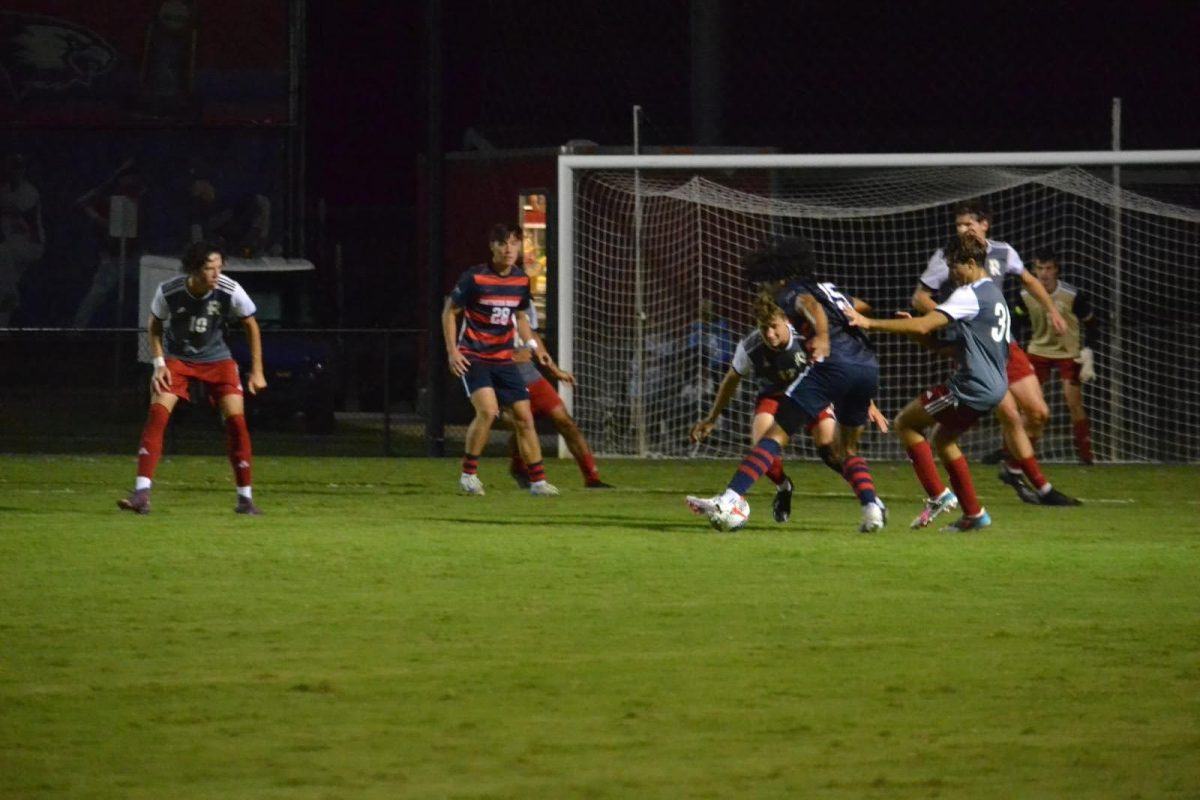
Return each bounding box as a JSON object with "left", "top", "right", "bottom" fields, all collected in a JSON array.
[{"left": 74, "top": 158, "right": 146, "bottom": 327}]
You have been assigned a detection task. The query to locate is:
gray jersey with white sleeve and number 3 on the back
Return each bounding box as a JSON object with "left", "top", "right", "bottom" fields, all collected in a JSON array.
[{"left": 936, "top": 278, "right": 1010, "bottom": 411}]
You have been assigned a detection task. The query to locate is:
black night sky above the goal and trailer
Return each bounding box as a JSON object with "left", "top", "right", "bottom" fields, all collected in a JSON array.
[{"left": 307, "top": 0, "right": 1200, "bottom": 207}]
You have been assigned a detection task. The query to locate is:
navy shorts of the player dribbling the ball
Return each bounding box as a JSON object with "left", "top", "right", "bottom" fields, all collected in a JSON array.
[{"left": 775, "top": 359, "right": 880, "bottom": 435}]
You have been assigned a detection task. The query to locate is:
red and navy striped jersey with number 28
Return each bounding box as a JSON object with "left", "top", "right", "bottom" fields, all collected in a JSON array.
[{"left": 450, "top": 264, "right": 533, "bottom": 361}]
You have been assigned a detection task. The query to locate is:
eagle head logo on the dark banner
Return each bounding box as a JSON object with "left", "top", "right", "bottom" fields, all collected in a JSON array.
[{"left": 0, "top": 12, "right": 116, "bottom": 101}]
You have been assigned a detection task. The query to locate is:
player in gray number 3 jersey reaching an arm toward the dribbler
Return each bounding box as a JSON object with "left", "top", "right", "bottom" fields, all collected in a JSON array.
[{"left": 846, "top": 234, "right": 1010, "bottom": 530}]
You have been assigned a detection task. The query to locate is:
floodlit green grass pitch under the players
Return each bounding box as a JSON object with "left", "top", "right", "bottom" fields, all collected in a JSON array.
[{"left": 0, "top": 456, "right": 1200, "bottom": 800}]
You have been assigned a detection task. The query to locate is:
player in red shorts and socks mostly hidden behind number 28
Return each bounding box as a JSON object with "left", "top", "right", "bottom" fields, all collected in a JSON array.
[{"left": 502, "top": 306, "right": 613, "bottom": 489}]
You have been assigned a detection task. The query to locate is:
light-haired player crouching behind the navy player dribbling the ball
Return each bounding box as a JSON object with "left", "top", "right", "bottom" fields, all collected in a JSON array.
[{"left": 689, "top": 294, "right": 888, "bottom": 523}]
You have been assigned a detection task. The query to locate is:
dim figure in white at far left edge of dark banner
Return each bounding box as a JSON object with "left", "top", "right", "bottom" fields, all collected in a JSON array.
[{"left": 0, "top": 154, "right": 46, "bottom": 327}]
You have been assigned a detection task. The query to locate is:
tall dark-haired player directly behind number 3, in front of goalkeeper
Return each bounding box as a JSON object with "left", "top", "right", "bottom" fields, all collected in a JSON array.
[{"left": 912, "top": 203, "right": 1079, "bottom": 506}]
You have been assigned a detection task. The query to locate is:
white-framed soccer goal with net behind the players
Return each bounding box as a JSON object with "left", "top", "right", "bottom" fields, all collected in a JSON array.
[{"left": 558, "top": 151, "right": 1200, "bottom": 462}]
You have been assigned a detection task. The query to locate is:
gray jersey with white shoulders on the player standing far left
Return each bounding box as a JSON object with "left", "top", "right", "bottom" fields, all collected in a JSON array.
[{"left": 150, "top": 275, "right": 257, "bottom": 362}]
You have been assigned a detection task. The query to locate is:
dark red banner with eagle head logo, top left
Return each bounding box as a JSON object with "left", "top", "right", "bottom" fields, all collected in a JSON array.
[{"left": 0, "top": 0, "right": 292, "bottom": 127}]
